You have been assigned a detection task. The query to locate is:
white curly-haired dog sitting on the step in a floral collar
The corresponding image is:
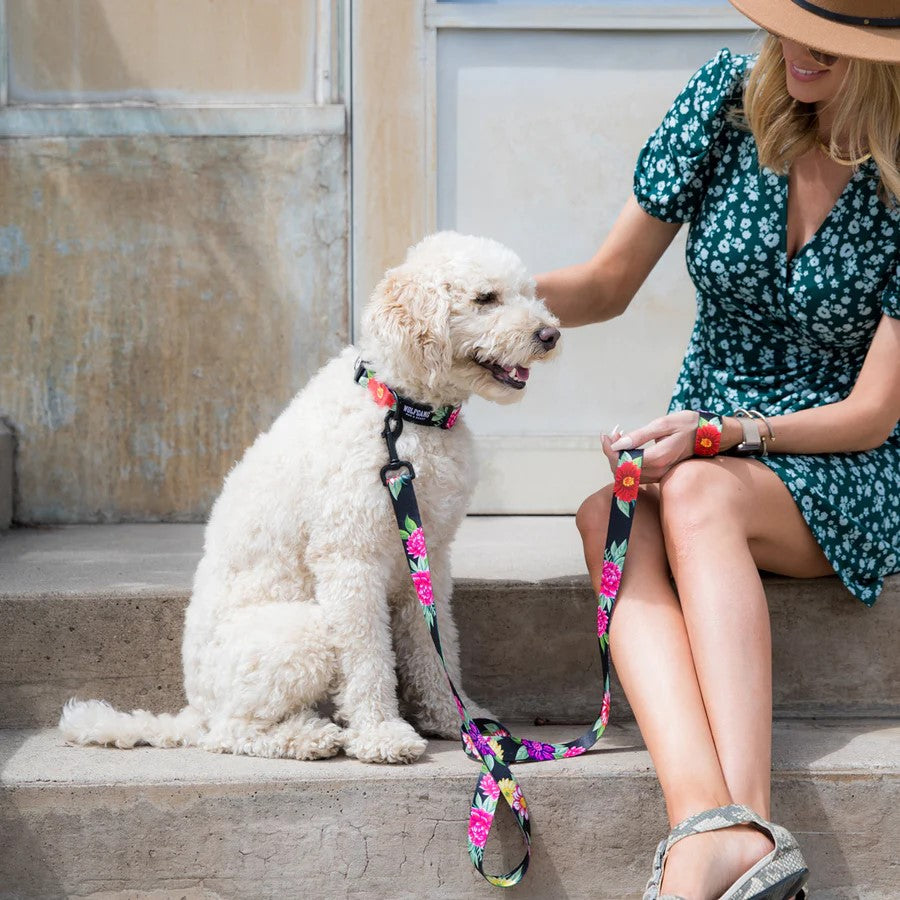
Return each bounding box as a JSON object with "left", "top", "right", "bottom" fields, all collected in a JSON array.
[{"left": 60, "top": 232, "right": 559, "bottom": 762}]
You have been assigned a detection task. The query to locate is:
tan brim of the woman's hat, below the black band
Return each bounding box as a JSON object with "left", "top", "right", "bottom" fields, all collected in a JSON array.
[{"left": 729, "top": 0, "right": 900, "bottom": 63}]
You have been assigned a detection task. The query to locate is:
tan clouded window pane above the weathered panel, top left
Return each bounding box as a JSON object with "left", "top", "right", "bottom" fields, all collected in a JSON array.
[{"left": 7, "top": 0, "right": 316, "bottom": 103}]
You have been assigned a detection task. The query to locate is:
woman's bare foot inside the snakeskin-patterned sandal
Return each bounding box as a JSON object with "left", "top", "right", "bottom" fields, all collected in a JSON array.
[{"left": 660, "top": 825, "right": 775, "bottom": 900}]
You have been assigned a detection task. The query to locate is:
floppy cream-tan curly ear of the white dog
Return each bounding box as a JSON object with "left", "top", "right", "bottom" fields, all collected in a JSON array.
[{"left": 363, "top": 265, "right": 453, "bottom": 388}]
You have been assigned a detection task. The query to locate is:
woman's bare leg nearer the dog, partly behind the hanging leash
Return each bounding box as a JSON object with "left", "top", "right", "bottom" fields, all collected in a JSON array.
[{"left": 576, "top": 486, "right": 771, "bottom": 898}]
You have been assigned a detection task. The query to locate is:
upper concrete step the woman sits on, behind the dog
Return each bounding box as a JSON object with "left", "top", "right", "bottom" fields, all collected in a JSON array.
[{"left": 0, "top": 517, "right": 900, "bottom": 727}]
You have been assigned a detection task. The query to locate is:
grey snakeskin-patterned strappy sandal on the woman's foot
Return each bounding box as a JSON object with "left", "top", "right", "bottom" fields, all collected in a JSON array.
[{"left": 644, "top": 804, "right": 809, "bottom": 900}]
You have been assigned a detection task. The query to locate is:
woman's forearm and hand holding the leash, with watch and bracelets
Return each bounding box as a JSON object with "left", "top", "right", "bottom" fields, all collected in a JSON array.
[{"left": 603, "top": 315, "right": 900, "bottom": 482}]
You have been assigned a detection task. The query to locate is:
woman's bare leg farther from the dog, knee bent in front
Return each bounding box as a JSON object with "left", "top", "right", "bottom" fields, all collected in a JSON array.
[{"left": 660, "top": 458, "right": 831, "bottom": 897}]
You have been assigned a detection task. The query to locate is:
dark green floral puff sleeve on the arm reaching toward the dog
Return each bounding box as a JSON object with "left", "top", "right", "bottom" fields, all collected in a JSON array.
[{"left": 634, "top": 50, "right": 751, "bottom": 222}]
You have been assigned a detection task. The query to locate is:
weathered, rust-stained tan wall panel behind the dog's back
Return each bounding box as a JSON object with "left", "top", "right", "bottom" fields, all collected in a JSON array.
[{"left": 0, "top": 136, "right": 349, "bottom": 522}]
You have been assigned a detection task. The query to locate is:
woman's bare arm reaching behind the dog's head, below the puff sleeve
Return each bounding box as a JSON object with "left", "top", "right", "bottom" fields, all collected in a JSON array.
[{"left": 537, "top": 197, "right": 681, "bottom": 328}]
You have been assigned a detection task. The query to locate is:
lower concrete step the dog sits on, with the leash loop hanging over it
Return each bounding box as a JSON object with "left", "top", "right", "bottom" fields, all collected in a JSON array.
[{"left": 0, "top": 720, "right": 900, "bottom": 900}]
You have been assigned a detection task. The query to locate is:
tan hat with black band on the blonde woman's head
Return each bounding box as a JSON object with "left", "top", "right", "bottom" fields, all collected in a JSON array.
[{"left": 730, "top": 0, "right": 900, "bottom": 63}]
